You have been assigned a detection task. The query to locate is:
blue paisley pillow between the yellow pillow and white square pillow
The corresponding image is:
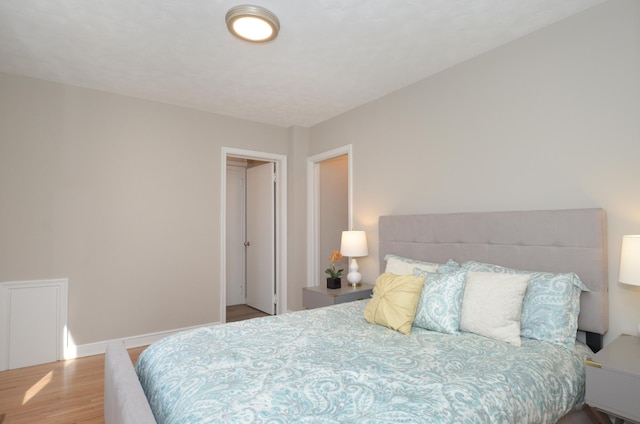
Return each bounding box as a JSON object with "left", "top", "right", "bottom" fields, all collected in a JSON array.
[{"left": 413, "top": 269, "right": 467, "bottom": 334}]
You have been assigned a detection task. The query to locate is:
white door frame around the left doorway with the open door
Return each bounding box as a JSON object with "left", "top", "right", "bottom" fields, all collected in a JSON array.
[{"left": 220, "top": 146, "right": 287, "bottom": 323}]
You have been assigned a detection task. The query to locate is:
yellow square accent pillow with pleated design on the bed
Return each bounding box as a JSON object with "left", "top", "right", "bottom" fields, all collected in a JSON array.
[{"left": 364, "top": 272, "right": 425, "bottom": 334}]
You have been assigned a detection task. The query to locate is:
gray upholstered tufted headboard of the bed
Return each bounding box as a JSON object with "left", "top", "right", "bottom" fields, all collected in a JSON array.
[{"left": 379, "top": 209, "right": 609, "bottom": 344}]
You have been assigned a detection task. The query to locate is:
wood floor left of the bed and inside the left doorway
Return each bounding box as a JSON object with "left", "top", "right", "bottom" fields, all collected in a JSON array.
[{"left": 0, "top": 305, "right": 267, "bottom": 424}]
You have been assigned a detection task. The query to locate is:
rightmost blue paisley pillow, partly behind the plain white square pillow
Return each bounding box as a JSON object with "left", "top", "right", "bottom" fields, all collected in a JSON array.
[{"left": 462, "top": 261, "right": 589, "bottom": 350}]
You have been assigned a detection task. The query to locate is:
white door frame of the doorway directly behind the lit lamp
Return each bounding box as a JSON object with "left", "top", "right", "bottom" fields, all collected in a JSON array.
[{"left": 307, "top": 144, "right": 353, "bottom": 287}]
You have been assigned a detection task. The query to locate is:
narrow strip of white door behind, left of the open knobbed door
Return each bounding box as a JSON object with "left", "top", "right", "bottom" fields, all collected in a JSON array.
[{"left": 226, "top": 166, "right": 246, "bottom": 305}]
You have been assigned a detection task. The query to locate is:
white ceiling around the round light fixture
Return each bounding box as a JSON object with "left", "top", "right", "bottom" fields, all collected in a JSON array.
[{"left": 0, "top": 0, "right": 604, "bottom": 127}]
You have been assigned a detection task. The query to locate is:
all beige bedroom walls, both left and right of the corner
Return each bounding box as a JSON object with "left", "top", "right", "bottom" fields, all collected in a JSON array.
[{"left": 0, "top": 0, "right": 640, "bottom": 352}]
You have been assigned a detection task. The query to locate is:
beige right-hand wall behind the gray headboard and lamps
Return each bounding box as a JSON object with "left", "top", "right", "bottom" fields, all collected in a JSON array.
[{"left": 309, "top": 0, "right": 640, "bottom": 340}]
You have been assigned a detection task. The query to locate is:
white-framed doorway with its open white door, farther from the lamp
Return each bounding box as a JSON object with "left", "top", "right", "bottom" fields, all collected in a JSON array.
[{"left": 220, "top": 148, "right": 287, "bottom": 322}]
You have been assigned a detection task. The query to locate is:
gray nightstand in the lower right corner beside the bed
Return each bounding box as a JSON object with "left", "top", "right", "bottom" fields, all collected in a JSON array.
[{"left": 585, "top": 334, "right": 640, "bottom": 423}]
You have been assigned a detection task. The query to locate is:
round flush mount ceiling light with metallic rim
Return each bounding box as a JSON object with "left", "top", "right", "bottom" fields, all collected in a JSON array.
[{"left": 226, "top": 5, "right": 280, "bottom": 43}]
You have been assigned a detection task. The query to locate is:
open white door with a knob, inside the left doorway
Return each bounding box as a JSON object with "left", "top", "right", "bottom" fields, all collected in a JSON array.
[{"left": 246, "top": 162, "right": 276, "bottom": 315}]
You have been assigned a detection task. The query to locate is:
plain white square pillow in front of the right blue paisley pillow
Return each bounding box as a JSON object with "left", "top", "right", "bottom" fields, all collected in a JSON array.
[{"left": 460, "top": 271, "right": 531, "bottom": 346}]
